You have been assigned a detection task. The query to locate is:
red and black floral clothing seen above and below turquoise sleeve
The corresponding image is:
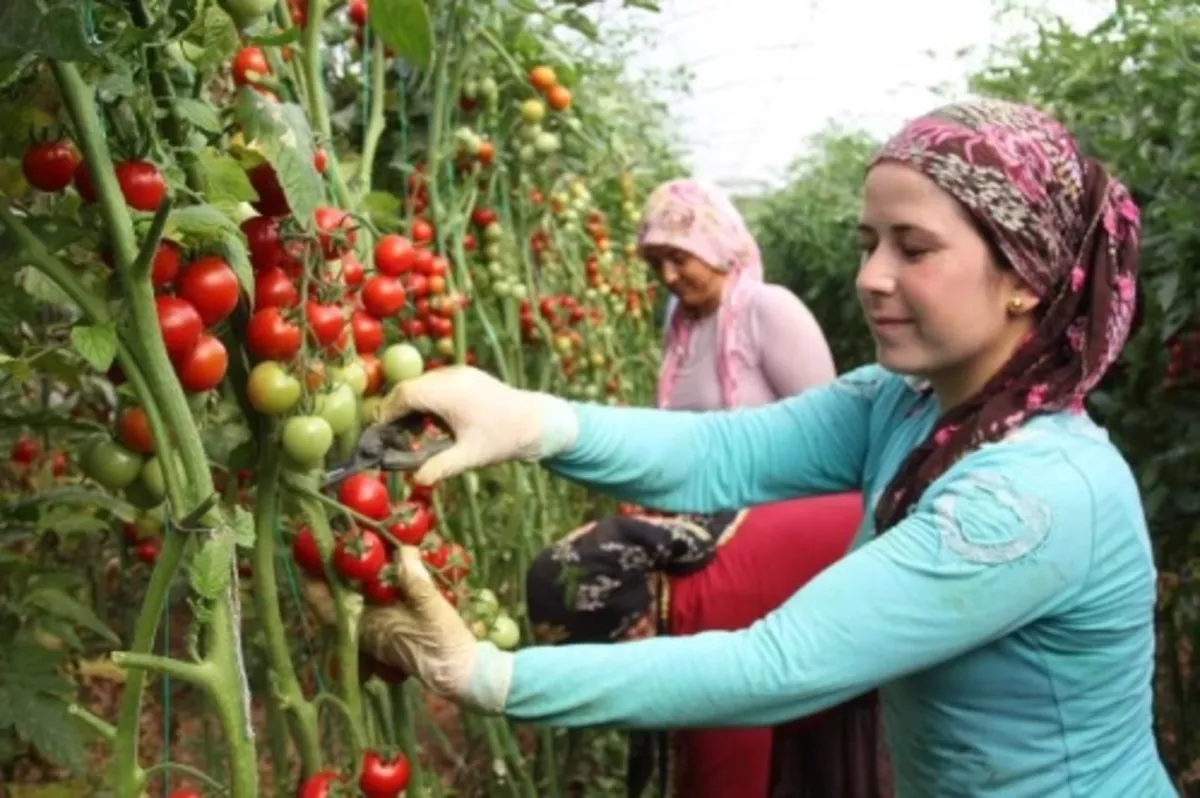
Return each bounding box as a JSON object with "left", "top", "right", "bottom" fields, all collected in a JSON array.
[{"left": 526, "top": 493, "right": 893, "bottom": 798}]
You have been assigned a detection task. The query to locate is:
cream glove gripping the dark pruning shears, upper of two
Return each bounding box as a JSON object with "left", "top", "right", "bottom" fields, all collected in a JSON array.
[{"left": 371, "top": 366, "right": 580, "bottom": 485}]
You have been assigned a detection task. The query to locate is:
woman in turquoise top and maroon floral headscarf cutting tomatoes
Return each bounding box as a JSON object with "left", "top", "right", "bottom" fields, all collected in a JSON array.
[{"left": 309, "top": 101, "right": 1176, "bottom": 798}]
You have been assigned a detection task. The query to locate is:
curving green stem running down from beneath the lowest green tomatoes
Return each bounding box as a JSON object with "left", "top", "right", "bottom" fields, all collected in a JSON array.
[{"left": 254, "top": 436, "right": 322, "bottom": 775}]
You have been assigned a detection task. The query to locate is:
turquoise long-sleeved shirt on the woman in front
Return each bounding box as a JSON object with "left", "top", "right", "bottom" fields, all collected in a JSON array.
[{"left": 487, "top": 366, "right": 1176, "bottom": 798}]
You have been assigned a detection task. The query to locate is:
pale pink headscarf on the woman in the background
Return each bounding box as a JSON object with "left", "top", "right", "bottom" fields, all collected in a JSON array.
[{"left": 637, "top": 179, "right": 762, "bottom": 408}]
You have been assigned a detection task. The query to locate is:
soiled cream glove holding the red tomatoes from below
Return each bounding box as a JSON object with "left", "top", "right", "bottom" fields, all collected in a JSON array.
[{"left": 304, "top": 546, "right": 512, "bottom": 714}]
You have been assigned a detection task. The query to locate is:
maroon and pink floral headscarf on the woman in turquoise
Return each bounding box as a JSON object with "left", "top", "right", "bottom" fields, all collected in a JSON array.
[{"left": 871, "top": 100, "right": 1141, "bottom": 533}]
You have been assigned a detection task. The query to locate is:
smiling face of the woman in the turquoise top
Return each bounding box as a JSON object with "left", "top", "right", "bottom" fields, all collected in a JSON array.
[{"left": 856, "top": 163, "right": 1037, "bottom": 409}]
